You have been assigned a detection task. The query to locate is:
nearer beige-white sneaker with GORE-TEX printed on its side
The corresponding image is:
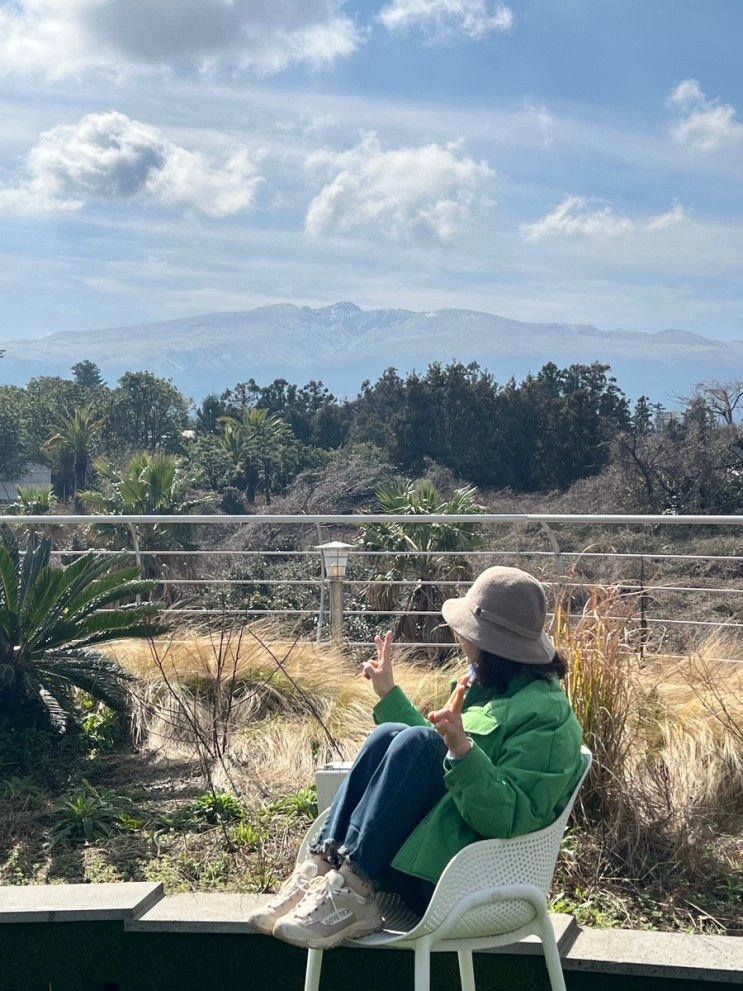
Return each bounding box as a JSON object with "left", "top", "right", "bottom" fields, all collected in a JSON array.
[{"left": 273, "top": 870, "right": 384, "bottom": 950}]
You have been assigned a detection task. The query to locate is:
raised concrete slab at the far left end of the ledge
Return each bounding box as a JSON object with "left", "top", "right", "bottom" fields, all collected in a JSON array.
[{"left": 0, "top": 881, "right": 163, "bottom": 923}]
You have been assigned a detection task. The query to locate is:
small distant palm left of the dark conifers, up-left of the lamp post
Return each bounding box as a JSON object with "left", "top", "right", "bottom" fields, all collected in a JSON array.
[{"left": 220, "top": 409, "right": 295, "bottom": 504}]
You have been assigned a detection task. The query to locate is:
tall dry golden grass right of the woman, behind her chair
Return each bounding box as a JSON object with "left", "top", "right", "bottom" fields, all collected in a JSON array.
[{"left": 554, "top": 587, "right": 743, "bottom": 881}]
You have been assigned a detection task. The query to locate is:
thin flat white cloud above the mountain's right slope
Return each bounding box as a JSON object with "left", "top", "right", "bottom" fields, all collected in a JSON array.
[{"left": 521, "top": 196, "right": 688, "bottom": 242}]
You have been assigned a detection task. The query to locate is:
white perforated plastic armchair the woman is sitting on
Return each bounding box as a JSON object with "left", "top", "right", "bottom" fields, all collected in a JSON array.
[{"left": 297, "top": 747, "right": 592, "bottom": 991}]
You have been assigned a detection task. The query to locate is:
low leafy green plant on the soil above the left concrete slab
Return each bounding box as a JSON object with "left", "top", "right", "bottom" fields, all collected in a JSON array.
[{"left": 50, "top": 780, "right": 141, "bottom": 846}]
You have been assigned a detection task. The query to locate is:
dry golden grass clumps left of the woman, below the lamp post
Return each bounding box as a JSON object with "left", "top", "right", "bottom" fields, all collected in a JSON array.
[{"left": 110, "top": 623, "right": 461, "bottom": 800}]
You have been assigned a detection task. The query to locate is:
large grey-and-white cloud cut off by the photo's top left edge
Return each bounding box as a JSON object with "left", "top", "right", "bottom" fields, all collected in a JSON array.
[{"left": 0, "top": 0, "right": 360, "bottom": 78}]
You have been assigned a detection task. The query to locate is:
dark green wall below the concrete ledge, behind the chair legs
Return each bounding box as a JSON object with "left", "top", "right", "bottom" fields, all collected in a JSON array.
[{"left": 0, "top": 922, "right": 721, "bottom": 991}]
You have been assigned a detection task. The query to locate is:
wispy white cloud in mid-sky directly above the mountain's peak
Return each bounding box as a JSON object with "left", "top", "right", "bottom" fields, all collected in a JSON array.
[{"left": 305, "top": 132, "right": 493, "bottom": 241}]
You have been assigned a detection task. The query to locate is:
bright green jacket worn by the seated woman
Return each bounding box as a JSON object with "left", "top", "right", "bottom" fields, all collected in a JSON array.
[{"left": 374, "top": 676, "right": 583, "bottom": 883}]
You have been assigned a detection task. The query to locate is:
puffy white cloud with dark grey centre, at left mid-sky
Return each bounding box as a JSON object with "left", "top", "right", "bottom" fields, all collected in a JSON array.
[{"left": 0, "top": 110, "right": 262, "bottom": 217}]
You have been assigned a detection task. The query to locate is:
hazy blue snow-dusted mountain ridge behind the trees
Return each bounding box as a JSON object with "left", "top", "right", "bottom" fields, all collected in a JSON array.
[{"left": 0, "top": 300, "right": 743, "bottom": 402}]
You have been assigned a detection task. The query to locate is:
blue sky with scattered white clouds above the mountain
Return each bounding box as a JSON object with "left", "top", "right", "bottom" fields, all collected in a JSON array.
[{"left": 0, "top": 0, "right": 743, "bottom": 340}]
